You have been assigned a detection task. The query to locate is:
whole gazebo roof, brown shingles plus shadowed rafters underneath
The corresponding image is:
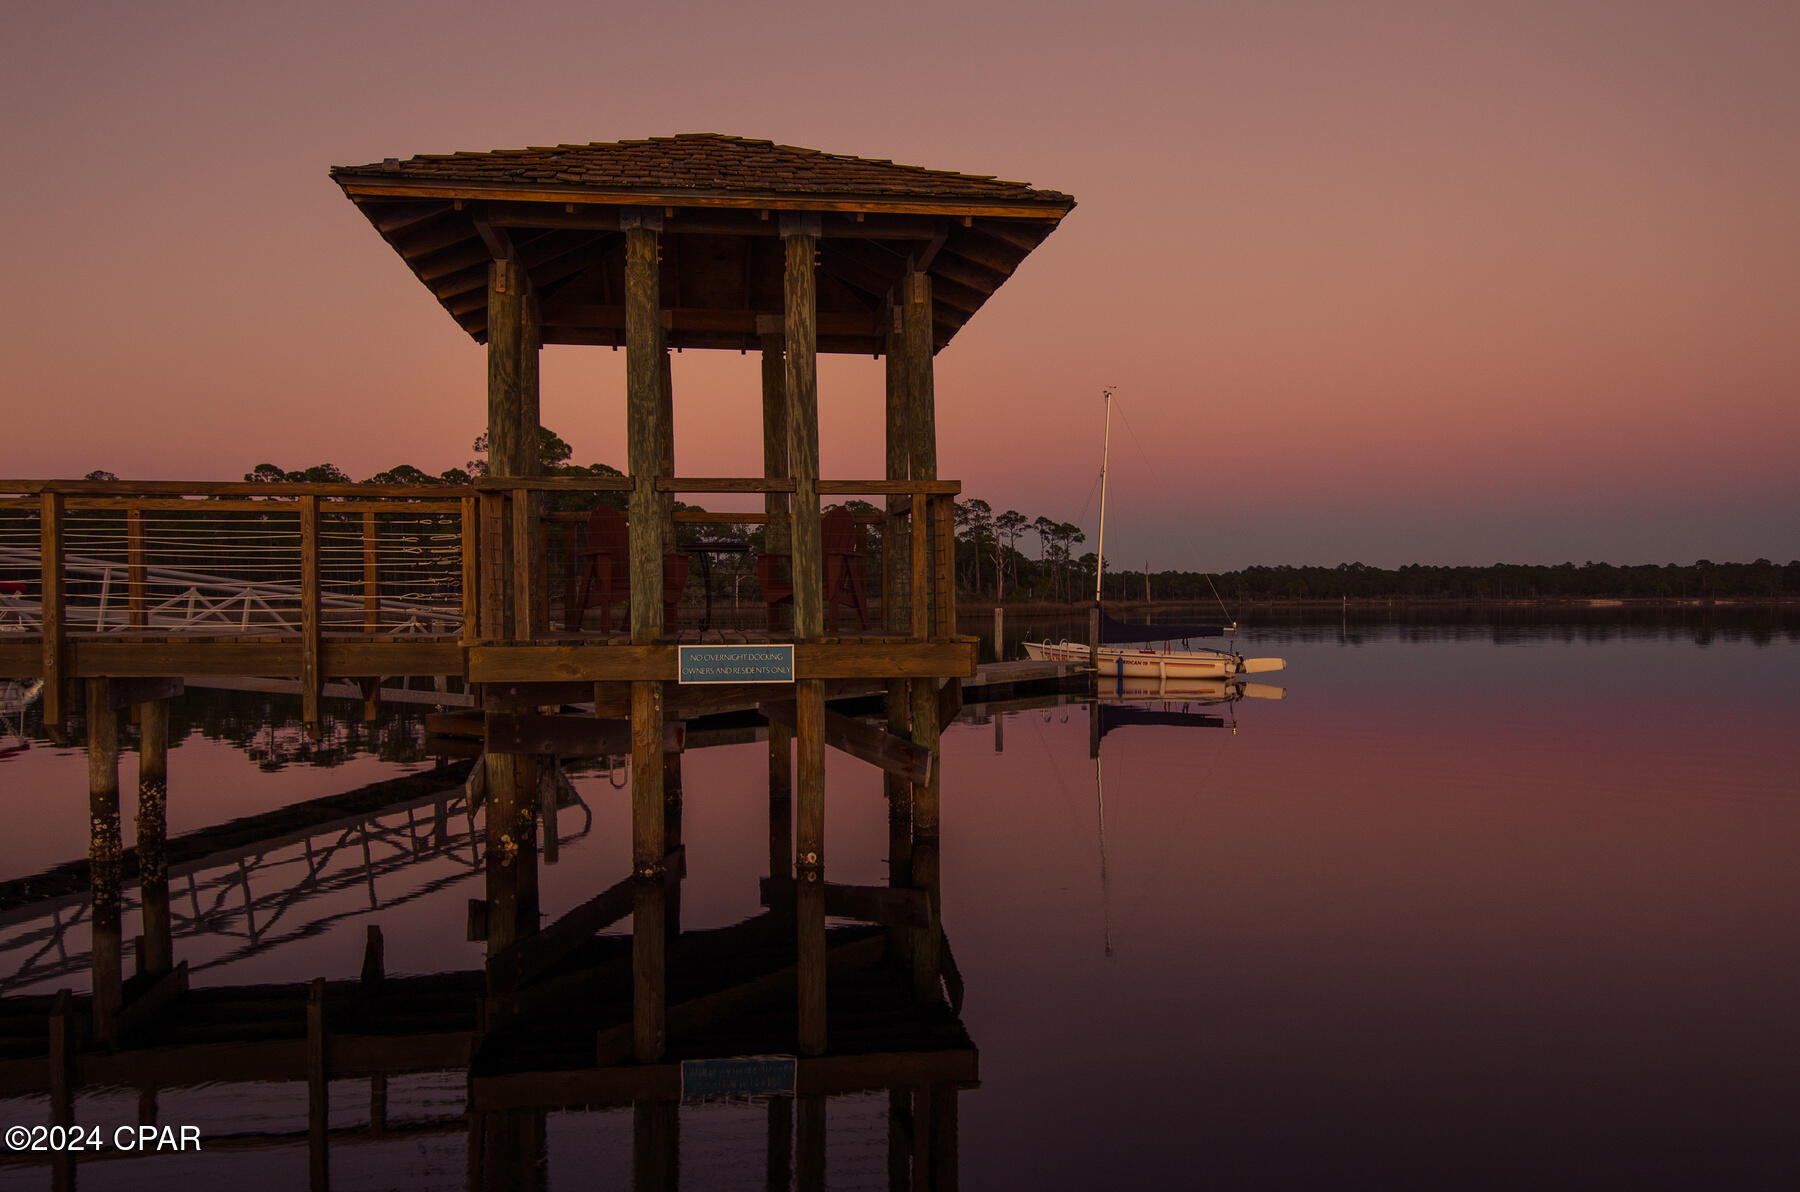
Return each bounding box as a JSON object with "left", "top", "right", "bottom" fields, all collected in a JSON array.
[{"left": 331, "top": 133, "right": 1075, "bottom": 353}]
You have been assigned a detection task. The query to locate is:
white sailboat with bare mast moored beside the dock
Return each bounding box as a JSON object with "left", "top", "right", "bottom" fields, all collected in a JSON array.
[{"left": 1024, "top": 389, "right": 1287, "bottom": 684}]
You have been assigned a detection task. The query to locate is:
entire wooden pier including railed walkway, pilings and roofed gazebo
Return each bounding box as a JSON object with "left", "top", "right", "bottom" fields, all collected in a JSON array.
[{"left": 0, "top": 135, "right": 1075, "bottom": 1183}]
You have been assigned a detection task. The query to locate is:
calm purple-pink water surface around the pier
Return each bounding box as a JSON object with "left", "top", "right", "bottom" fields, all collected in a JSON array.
[{"left": 0, "top": 616, "right": 1800, "bottom": 1188}]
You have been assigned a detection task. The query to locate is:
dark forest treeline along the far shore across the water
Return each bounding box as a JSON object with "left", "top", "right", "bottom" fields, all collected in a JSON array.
[{"left": 66, "top": 429, "right": 1800, "bottom": 605}]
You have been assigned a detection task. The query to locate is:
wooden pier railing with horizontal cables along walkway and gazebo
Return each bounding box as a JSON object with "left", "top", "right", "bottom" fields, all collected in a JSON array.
[{"left": 0, "top": 477, "right": 959, "bottom": 666}]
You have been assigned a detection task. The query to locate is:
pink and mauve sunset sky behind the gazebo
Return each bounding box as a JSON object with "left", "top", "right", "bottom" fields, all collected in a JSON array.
[{"left": 0, "top": 0, "right": 1800, "bottom": 569}]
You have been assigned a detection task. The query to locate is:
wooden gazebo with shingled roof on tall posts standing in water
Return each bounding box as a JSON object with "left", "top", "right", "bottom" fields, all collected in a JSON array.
[{"left": 331, "top": 133, "right": 1075, "bottom": 1061}]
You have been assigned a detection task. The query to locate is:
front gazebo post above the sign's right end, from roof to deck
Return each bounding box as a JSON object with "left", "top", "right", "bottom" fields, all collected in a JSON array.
[{"left": 781, "top": 216, "right": 824, "bottom": 641}]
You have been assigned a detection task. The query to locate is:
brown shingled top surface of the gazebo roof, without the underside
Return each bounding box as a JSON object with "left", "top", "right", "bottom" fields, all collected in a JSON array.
[{"left": 331, "top": 133, "right": 1073, "bottom": 207}]
